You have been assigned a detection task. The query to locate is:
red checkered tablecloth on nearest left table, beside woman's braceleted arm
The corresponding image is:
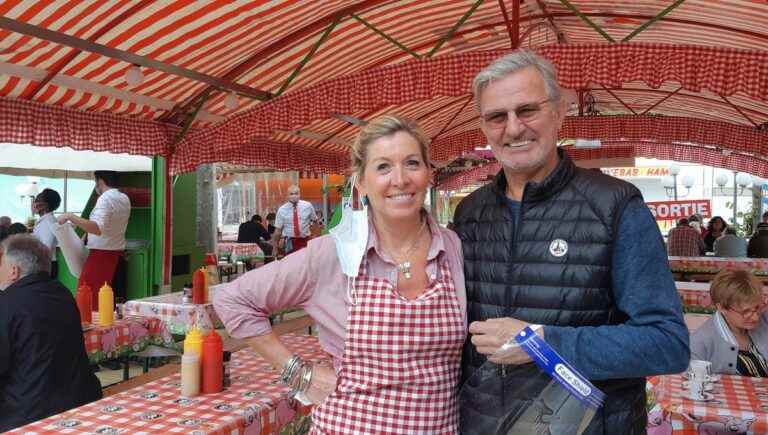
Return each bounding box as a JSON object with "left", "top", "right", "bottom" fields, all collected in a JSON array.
[{"left": 10, "top": 334, "right": 330, "bottom": 435}]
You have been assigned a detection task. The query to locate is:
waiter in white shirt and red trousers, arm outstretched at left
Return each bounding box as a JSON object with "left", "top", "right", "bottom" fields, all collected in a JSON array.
[{"left": 58, "top": 171, "right": 131, "bottom": 307}]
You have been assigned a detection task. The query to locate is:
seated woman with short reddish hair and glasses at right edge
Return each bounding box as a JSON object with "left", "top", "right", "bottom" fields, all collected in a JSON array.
[{"left": 691, "top": 269, "right": 768, "bottom": 377}]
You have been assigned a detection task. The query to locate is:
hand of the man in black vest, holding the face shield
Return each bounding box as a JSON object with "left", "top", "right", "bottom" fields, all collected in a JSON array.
[{"left": 469, "top": 317, "right": 543, "bottom": 364}]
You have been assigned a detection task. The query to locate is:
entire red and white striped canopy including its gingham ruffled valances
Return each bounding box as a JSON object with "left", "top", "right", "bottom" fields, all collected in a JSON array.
[{"left": 0, "top": 0, "right": 768, "bottom": 176}]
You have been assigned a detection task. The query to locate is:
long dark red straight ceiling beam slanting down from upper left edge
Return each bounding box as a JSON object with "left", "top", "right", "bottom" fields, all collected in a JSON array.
[{"left": 0, "top": 17, "right": 272, "bottom": 100}]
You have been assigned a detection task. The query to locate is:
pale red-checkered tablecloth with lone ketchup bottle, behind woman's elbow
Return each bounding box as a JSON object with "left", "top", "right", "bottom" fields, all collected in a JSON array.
[{"left": 123, "top": 292, "right": 222, "bottom": 335}]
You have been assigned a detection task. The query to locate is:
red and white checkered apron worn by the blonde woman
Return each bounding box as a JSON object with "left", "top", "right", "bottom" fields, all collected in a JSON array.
[{"left": 312, "top": 255, "right": 467, "bottom": 434}]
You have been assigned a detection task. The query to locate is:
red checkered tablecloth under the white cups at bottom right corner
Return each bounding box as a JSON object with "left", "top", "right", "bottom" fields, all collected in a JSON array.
[{"left": 648, "top": 374, "right": 768, "bottom": 435}]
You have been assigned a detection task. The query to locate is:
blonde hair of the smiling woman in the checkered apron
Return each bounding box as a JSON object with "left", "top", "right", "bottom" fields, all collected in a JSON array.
[{"left": 350, "top": 115, "right": 429, "bottom": 177}]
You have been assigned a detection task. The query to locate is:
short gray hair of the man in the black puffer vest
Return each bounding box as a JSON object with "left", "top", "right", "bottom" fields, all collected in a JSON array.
[{"left": 472, "top": 48, "right": 560, "bottom": 108}]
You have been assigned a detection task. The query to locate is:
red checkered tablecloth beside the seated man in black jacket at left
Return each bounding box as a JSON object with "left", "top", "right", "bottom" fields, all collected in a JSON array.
[{"left": 83, "top": 313, "right": 175, "bottom": 364}]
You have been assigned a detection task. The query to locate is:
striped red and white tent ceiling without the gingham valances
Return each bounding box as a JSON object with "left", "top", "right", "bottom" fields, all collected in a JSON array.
[{"left": 0, "top": 0, "right": 768, "bottom": 177}]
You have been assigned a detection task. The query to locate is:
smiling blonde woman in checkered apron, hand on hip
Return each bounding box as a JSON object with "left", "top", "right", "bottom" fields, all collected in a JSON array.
[{"left": 214, "top": 116, "right": 466, "bottom": 434}]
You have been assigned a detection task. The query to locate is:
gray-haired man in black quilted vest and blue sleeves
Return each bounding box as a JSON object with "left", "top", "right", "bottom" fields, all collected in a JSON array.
[{"left": 454, "top": 50, "right": 689, "bottom": 434}]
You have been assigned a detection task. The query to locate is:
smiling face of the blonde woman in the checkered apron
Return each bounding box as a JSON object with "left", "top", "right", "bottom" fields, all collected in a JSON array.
[{"left": 358, "top": 131, "right": 432, "bottom": 220}]
